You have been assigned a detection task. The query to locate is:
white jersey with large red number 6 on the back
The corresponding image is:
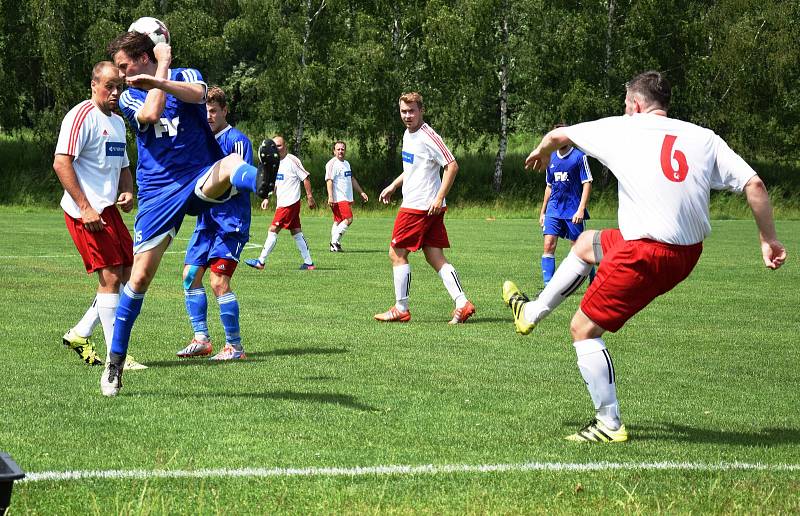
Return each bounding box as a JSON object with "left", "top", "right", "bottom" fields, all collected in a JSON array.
[{"left": 565, "top": 114, "right": 756, "bottom": 245}]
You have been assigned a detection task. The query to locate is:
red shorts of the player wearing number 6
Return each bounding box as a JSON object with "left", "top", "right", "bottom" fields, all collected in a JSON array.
[{"left": 581, "top": 229, "right": 703, "bottom": 331}]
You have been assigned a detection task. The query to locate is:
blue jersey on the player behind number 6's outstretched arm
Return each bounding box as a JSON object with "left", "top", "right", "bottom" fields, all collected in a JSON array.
[{"left": 545, "top": 147, "right": 592, "bottom": 219}]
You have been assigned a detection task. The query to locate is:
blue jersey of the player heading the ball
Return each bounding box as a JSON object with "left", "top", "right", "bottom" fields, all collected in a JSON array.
[{"left": 119, "top": 68, "right": 224, "bottom": 205}]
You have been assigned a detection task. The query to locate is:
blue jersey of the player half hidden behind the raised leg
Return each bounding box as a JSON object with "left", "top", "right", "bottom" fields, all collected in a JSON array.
[{"left": 197, "top": 126, "right": 253, "bottom": 238}]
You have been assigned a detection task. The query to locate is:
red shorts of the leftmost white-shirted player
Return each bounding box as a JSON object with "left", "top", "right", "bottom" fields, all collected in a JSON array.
[{"left": 64, "top": 206, "right": 133, "bottom": 274}]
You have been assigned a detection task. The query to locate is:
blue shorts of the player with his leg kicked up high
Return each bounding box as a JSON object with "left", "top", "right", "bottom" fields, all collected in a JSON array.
[{"left": 133, "top": 163, "right": 236, "bottom": 254}]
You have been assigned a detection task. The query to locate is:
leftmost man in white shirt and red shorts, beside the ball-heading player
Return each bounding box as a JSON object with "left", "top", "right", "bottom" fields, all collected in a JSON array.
[{"left": 53, "top": 61, "right": 139, "bottom": 365}]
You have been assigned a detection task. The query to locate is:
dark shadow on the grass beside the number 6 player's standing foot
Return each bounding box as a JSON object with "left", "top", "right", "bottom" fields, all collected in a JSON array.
[{"left": 564, "top": 421, "right": 800, "bottom": 447}]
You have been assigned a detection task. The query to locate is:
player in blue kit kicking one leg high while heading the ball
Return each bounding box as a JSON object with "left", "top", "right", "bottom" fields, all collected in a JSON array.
[{"left": 100, "top": 32, "right": 280, "bottom": 396}]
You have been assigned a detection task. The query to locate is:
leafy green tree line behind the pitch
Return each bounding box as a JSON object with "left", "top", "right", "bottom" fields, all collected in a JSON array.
[{"left": 0, "top": 0, "right": 800, "bottom": 196}]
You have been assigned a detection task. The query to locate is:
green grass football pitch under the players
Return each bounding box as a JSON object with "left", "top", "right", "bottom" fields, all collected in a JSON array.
[{"left": 0, "top": 208, "right": 800, "bottom": 515}]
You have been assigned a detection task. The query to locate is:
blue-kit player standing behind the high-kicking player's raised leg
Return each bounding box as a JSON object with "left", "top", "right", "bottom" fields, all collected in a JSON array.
[{"left": 177, "top": 86, "right": 253, "bottom": 360}]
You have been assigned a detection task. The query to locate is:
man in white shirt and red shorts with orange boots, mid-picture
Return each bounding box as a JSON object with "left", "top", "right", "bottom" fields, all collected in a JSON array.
[{"left": 375, "top": 92, "right": 475, "bottom": 324}]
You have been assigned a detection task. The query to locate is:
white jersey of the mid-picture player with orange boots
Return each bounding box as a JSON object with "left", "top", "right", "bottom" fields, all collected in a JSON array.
[{"left": 400, "top": 123, "right": 455, "bottom": 211}]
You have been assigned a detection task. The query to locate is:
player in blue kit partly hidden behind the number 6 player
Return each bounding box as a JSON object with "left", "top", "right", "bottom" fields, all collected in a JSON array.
[{"left": 539, "top": 124, "right": 594, "bottom": 285}]
